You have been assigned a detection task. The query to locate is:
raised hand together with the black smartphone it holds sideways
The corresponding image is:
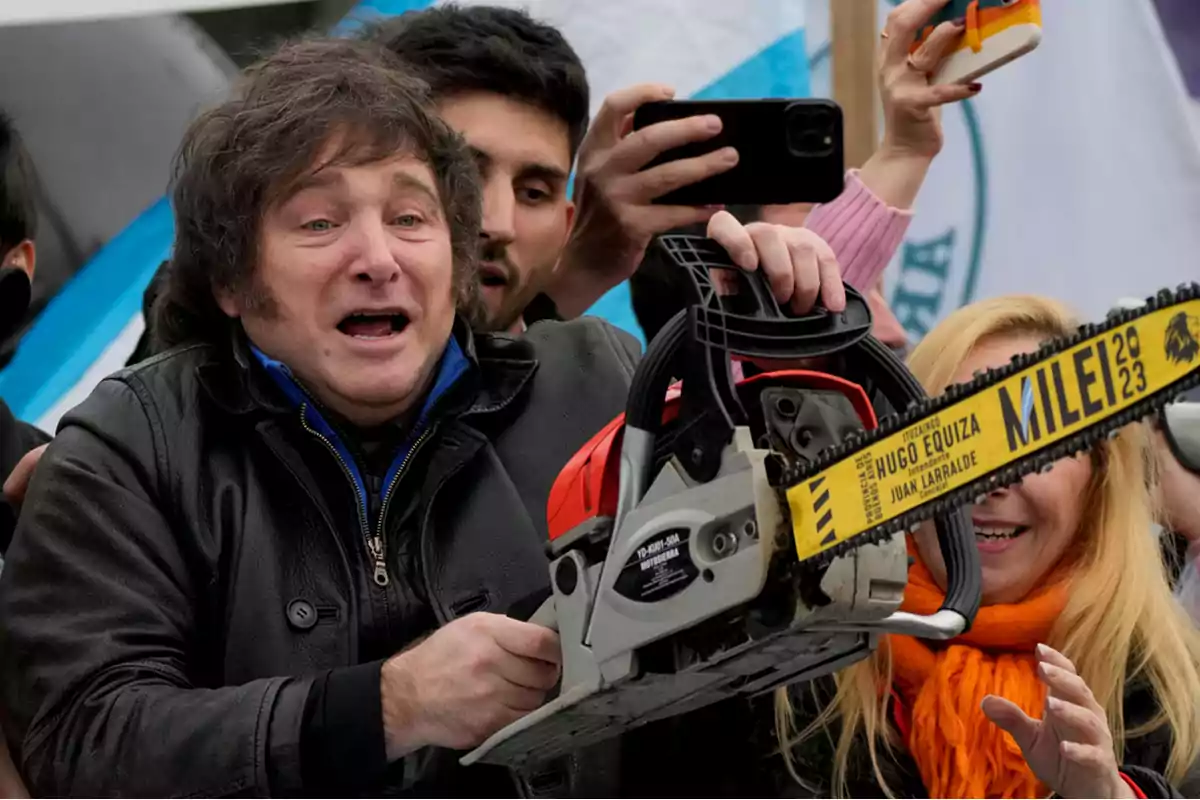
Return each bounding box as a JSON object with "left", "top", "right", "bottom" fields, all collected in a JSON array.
[{"left": 547, "top": 84, "right": 844, "bottom": 318}]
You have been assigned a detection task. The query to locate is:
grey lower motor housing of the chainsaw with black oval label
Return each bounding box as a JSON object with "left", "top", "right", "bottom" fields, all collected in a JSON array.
[{"left": 468, "top": 391, "right": 908, "bottom": 765}]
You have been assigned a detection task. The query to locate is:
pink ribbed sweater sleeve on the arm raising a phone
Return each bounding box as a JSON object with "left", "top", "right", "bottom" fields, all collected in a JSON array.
[{"left": 804, "top": 169, "right": 912, "bottom": 291}]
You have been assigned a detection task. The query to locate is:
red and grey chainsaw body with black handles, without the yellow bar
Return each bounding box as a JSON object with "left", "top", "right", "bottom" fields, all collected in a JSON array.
[{"left": 462, "top": 236, "right": 979, "bottom": 768}]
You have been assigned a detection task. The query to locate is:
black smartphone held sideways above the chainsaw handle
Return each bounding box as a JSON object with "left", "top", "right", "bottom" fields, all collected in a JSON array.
[{"left": 634, "top": 100, "right": 846, "bottom": 205}]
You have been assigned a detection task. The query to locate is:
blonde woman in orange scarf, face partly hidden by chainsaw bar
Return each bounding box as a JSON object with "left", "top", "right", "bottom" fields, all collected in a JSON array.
[{"left": 776, "top": 296, "right": 1200, "bottom": 798}]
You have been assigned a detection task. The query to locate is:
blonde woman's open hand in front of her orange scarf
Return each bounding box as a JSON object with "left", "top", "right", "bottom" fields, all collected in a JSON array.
[{"left": 983, "top": 644, "right": 1135, "bottom": 798}]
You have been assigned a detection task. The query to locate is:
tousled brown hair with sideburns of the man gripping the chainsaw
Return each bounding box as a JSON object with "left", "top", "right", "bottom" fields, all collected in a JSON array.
[{"left": 154, "top": 38, "right": 481, "bottom": 349}]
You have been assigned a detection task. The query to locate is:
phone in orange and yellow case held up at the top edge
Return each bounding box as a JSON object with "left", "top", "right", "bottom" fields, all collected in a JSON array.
[{"left": 912, "top": 0, "right": 1042, "bottom": 84}]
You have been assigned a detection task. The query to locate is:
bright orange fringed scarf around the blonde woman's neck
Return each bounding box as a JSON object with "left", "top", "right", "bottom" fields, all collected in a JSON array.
[{"left": 888, "top": 546, "right": 1067, "bottom": 798}]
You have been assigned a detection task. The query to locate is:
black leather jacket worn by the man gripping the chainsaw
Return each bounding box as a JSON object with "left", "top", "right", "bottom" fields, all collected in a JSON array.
[{"left": 0, "top": 319, "right": 638, "bottom": 796}]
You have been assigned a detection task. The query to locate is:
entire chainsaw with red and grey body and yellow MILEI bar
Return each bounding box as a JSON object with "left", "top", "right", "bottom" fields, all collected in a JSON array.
[{"left": 461, "top": 235, "right": 1200, "bottom": 770}]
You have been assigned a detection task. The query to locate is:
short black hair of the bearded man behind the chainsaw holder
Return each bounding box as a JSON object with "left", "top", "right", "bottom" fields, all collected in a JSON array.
[{"left": 364, "top": 4, "right": 589, "bottom": 161}]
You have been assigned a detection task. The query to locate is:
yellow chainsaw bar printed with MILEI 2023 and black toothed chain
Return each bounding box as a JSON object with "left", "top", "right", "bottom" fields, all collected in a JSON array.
[{"left": 784, "top": 284, "right": 1200, "bottom": 564}]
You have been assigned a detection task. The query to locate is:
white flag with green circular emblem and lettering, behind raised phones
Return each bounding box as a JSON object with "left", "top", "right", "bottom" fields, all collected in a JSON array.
[{"left": 805, "top": 0, "right": 1200, "bottom": 338}]
